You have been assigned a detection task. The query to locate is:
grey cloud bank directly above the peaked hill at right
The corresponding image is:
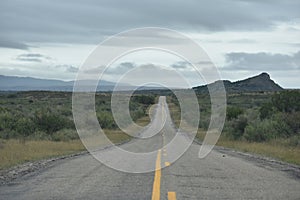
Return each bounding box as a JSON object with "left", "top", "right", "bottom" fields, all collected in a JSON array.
[{"left": 223, "top": 51, "right": 300, "bottom": 71}]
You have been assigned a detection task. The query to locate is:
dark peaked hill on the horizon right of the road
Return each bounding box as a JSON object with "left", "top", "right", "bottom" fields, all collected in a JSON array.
[{"left": 193, "top": 73, "right": 283, "bottom": 93}]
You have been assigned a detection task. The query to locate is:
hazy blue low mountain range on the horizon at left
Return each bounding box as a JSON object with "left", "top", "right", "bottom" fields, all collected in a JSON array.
[{"left": 0, "top": 75, "right": 118, "bottom": 91}]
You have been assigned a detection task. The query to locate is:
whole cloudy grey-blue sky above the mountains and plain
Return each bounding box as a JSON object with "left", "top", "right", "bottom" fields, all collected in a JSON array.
[{"left": 0, "top": 0, "right": 300, "bottom": 88}]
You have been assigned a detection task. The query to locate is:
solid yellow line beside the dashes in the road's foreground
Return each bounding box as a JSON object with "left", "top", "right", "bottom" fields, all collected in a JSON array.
[{"left": 152, "top": 150, "right": 161, "bottom": 200}]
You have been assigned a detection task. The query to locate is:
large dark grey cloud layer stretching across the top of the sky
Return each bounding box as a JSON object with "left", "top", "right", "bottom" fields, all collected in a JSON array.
[{"left": 0, "top": 0, "right": 300, "bottom": 45}]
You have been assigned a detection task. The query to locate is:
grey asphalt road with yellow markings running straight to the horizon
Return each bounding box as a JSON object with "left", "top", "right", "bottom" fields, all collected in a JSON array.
[{"left": 0, "top": 97, "right": 300, "bottom": 200}]
